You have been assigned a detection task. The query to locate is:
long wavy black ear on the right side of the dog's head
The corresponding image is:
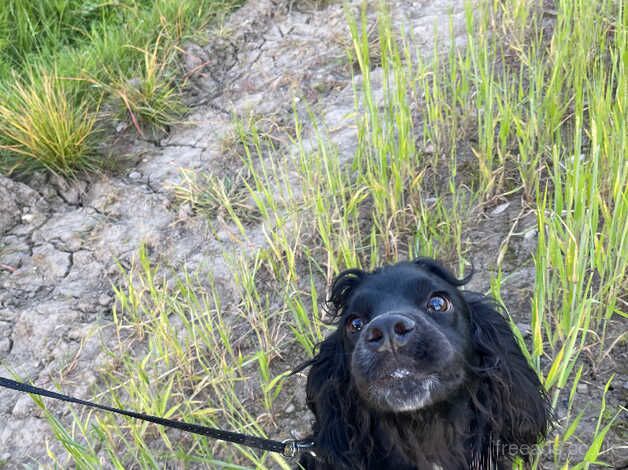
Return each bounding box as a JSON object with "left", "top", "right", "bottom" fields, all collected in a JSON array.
[{"left": 465, "top": 293, "right": 551, "bottom": 445}]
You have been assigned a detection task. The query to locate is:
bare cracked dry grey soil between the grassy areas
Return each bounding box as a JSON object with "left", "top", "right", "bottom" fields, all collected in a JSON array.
[{"left": 0, "top": 0, "right": 624, "bottom": 468}]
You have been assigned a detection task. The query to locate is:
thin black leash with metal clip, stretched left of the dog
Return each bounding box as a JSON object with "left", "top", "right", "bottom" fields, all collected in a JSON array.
[{"left": 0, "top": 377, "right": 314, "bottom": 457}]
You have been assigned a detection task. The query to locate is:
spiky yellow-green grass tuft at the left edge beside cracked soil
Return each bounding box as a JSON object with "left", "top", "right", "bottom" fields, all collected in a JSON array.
[{"left": 0, "top": 71, "right": 96, "bottom": 177}]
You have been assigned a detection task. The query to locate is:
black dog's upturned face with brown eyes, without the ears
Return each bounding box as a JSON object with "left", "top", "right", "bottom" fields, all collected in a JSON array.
[{"left": 340, "top": 263, "right": 471, "bottom": 412}]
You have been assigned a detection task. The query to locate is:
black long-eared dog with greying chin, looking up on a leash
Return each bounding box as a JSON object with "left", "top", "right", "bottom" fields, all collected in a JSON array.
[{"left": 298, "top": 258, "right": 550, "bottom": 470}]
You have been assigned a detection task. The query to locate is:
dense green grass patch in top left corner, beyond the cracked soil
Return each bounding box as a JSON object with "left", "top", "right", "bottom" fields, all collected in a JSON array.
[{"left": 0, "top": 0, "right": 241, "bottom": 177}]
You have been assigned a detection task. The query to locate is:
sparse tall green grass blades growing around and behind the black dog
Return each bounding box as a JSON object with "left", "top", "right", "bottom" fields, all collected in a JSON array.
[{"left": 29, "top": 0, "right": 628, "bottom": 469}]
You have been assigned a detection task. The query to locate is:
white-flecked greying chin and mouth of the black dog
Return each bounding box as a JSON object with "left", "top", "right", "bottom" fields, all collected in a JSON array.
[{"left": 358, "top": 369, "right": 441, "bottom": 413}]
